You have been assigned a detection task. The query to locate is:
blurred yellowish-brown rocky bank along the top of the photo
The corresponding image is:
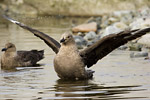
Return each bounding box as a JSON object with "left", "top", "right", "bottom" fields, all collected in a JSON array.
[{"left": 0, "top": 0, "right": 150, "bottom": 16}]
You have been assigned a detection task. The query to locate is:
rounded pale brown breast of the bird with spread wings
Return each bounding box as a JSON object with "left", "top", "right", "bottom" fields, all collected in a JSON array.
[{"left": 54, "top": 50, "right": 84, "bottom": 74}]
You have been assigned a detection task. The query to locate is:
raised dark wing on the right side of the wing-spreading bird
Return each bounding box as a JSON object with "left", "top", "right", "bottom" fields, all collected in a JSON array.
[{"left": 80, "top": 28, "right": 150, "bottom": 68}]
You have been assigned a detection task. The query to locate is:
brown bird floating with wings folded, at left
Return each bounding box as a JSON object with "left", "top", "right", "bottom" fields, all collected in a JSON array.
[{"left": 1, "top": 43, "right": 44, "bottom": 69}]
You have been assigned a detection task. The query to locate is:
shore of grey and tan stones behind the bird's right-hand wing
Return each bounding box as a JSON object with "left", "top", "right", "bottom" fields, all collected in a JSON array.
[{"left": 72, "top": 8, "right": 150, "bottom": 58}]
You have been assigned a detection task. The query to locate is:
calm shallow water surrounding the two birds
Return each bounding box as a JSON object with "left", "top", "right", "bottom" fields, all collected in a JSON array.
[{"left": 0, "top": 17, "right": 150, "bottom": 100}]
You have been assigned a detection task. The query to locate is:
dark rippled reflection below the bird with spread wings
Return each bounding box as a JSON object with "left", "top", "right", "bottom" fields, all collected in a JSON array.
[{"left": 39, "top": 80, "right": 143, "bottom": 100}]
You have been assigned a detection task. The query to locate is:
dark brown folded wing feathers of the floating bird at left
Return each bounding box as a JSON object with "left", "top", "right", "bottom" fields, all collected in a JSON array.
[{"left": 16, "top": 50, "right": 44, "bottom": 65}]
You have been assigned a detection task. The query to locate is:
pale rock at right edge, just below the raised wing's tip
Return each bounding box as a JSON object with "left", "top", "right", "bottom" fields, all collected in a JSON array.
[{"left": 137, "top": 34, "right": 150, "bottom": 47}]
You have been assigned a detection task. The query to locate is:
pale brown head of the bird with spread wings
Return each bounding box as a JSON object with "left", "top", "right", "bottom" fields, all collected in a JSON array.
[{"left": 60, "top": 32, "right": 75, "bottom": 45}]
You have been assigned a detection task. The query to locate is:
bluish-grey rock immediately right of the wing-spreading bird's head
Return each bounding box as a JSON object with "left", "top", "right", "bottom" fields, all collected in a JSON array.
[{"left": 74, "top": 36, "right": 87, "bottom": 49}]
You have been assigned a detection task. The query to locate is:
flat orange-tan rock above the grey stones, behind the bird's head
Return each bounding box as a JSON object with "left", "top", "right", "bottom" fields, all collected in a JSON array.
[{"left": 72, "top": 22, "right": 97, "bottom": 32}]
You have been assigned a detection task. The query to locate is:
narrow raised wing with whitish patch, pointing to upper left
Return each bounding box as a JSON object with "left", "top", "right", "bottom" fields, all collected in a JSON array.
[{"left": 3, "top": 15, "right": 60, "bottom": 54}]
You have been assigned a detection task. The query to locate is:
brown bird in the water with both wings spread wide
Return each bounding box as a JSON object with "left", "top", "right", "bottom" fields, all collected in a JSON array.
[{"left": 4, "top": 16, "right": 150, "bottom": 79}]
